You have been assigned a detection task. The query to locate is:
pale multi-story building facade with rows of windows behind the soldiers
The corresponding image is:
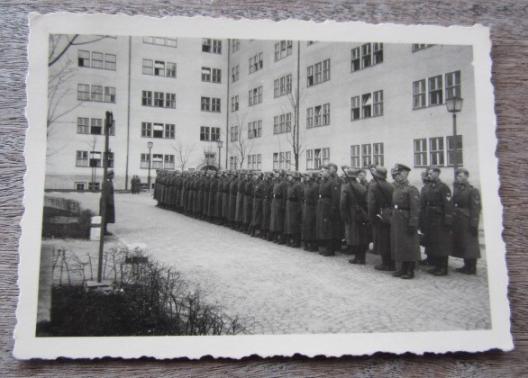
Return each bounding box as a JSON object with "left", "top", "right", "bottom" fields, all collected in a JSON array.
[{"left": 46, "top": 37, "right": 479, "bottom": 189}]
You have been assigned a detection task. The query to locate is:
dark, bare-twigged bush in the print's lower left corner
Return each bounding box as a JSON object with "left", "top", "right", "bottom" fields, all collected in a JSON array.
[{"left": 37, "top": 251, "right": 243, "bottom": 336}]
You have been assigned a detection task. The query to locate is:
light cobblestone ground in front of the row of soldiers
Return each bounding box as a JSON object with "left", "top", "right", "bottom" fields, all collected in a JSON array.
[{"left": 49, "top": 193, "right": 491, "bottom": 334}]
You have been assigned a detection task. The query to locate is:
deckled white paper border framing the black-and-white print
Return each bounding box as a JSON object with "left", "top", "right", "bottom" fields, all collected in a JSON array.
[{"left": 14, "top": 13, "right": 513, "bottom": 359}]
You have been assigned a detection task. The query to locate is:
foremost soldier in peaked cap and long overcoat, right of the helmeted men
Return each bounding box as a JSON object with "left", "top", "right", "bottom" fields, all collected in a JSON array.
[{"left": 391, "top": 164, "right": 420, "bottom": 279}]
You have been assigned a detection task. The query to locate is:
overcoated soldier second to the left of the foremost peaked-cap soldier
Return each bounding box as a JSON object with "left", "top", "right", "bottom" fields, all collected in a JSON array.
[{"left": 339, "top": 167, "right": 368, "bottom": 265}]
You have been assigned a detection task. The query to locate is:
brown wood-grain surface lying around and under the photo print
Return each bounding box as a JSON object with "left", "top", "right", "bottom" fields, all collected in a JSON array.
[{"left": 0, "top": 0, "right": 528, "bottom": 377}]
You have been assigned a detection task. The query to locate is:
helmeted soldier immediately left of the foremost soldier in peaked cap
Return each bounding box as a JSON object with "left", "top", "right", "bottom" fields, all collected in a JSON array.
[{"left": 367, "top": 166, "right": 396, "bottom": 271}]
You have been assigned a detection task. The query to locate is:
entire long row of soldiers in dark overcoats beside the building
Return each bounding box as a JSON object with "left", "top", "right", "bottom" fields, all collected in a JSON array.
[{"left": 154, "top": 163, "right": 480, "bottom": 279}]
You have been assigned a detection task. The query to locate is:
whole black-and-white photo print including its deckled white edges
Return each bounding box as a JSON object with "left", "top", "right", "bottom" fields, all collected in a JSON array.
[{"left": 17, "top": 15, "right": 511, "bottom": 357}]
